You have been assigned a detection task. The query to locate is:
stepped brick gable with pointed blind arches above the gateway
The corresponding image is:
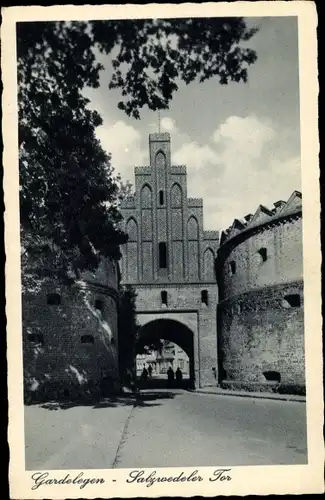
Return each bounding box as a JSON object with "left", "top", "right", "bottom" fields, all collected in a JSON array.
[{"left": 121, "top": 134, "right": 219, "bottom": 290}]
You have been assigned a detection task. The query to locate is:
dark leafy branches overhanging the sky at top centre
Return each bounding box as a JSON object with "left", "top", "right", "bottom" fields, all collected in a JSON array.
[{"left": 91, "top": 18, "right": 257, "bottom": 118}]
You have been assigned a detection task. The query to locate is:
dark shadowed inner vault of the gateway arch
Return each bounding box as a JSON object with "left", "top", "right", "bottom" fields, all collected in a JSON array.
[{"left": 138, "top": 319, "right": 195, "bottom": 387}]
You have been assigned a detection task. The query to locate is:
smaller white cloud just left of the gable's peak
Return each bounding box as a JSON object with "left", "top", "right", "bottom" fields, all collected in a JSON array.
[{"left": 96, "top": 120, "right": 147, "bottom": 183}]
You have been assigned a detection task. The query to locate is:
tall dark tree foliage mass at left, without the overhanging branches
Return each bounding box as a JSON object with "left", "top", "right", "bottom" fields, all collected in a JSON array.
[{"left": 17, "top": 23, "right": 126, "bottom": 271}]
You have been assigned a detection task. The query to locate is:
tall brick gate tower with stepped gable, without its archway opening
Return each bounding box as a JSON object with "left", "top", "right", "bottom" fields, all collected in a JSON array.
[{"left": 121, "top": 133, "right": 219, "bottom": 387}]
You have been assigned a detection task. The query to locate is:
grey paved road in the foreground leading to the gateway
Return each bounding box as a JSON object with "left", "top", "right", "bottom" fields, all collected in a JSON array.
[{"left": 25, "top": 389, "right": 307, "bottom": 470}]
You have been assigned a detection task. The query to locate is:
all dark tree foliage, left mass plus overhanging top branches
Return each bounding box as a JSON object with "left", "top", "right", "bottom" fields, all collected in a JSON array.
[{"left": 17, "top": 18, "right": 256, "bottom": 276}]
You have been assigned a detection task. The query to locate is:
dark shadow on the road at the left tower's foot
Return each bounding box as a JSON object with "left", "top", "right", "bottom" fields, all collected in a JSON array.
[{"left": 31, "top": 391, "right": 176, "bottom": 411}]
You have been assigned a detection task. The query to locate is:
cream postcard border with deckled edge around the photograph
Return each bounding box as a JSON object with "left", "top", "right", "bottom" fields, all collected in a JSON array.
[{"left": 1, "top": 1, "right": 324, "bottom": 499}]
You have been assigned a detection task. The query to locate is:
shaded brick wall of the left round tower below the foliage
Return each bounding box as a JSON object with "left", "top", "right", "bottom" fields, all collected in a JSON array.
[{"left": 22, "top": 260, "right": 118, "bottom": 399}]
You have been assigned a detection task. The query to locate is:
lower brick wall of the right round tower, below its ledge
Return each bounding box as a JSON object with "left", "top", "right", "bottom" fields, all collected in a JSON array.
[{"left": 218, "top": 282, "right": 305, "bottom": 387}]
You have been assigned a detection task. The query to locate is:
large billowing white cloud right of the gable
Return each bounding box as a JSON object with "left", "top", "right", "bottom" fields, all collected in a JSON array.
[{"left": 173, "top": 115, "right": 300, "bottom": 229}]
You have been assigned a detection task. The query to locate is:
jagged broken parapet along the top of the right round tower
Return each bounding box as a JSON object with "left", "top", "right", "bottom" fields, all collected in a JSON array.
[{"left": 220, "top": 191, "right": 302, "bottom": 245}]
